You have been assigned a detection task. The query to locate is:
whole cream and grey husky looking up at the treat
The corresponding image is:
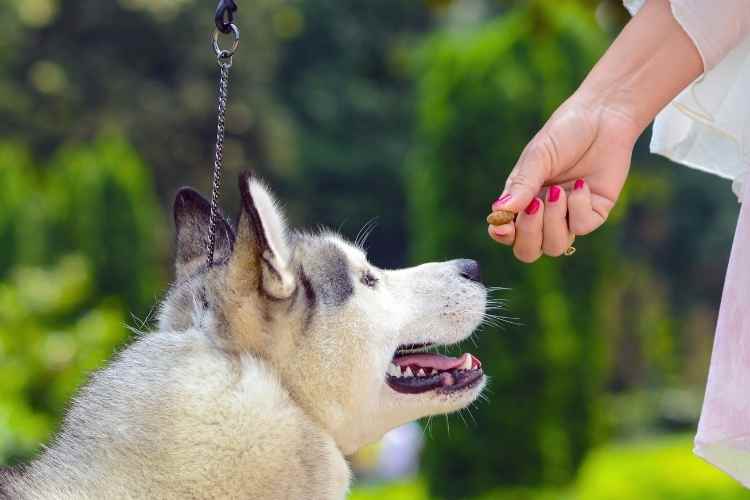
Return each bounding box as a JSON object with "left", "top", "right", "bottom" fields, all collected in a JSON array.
[{"left": 0, "top": 174, "right": 487, "bottom": 500}]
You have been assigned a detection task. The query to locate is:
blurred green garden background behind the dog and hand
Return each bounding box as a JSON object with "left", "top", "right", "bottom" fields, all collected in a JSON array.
[{"left": 0, "top": 0, "right": 749, "bottom": 500}]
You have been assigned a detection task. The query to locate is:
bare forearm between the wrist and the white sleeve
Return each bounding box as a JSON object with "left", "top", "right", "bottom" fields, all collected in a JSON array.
[{"left": 576, "top": 0, "right": 703, "bottom": 134}]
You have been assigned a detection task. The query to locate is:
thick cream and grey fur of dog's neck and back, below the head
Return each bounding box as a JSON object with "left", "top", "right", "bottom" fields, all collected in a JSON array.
[{"left": 0, "top": 330, "right": 349, "bottom": 499}]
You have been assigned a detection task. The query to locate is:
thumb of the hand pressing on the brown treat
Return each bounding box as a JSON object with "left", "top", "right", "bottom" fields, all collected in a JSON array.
[{"left": 492, "top": 133, "right": 556, "bottom": 213}]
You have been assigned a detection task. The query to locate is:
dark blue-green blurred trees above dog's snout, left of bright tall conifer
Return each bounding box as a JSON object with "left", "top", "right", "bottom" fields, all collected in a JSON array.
[{"left": 276, "top": 0, "right": 428, "bottom": 267}]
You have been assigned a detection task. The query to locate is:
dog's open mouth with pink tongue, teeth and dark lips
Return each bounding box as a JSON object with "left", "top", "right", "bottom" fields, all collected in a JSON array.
[{"left": 386, "top": 345, "right": 484, "bottom": 394}]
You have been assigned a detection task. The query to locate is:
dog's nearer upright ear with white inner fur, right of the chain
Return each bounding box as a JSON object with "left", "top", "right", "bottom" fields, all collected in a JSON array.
[{"left": 229, "top": 173, "right": 297, "bottom": 300}]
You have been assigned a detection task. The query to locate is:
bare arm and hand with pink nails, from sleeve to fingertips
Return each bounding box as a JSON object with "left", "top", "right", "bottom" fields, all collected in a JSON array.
[{"left": 488, "top": 0, "right": 703, "bottom": 262}]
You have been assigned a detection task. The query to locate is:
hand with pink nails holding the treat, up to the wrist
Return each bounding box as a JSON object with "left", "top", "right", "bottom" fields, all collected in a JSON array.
[{"left": 488, "top": 95, "right": 641, "bottom": 262}]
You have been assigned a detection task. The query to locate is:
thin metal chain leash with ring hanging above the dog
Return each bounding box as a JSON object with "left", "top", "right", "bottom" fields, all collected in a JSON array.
[{"left": 206, "top": 19, "right": 240, "bottom": 267}]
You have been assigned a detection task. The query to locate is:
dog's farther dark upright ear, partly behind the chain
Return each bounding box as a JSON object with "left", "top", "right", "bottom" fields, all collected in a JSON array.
[{"left": 174, "top": 188, "right": 234, "bottom": 280}]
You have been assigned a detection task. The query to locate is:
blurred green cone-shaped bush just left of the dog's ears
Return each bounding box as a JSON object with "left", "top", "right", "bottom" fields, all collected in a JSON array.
[{"left": 47, "top": 138, "right": 166, "bottom": 316}]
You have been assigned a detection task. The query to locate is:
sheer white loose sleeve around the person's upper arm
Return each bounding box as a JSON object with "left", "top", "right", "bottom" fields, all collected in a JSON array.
[{"left": 624, "top": 0, "right": 750, "bottom": 201}]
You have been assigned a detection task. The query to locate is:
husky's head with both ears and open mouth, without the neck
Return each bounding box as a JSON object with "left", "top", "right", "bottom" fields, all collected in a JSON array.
[{"left": 160, "top": 175, "right": 487, "bottom": 453}]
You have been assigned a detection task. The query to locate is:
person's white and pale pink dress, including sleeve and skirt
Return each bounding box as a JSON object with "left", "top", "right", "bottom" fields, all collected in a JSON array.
[{"left": 625, "top": 0, "right": 750, "bottom": 487}]
